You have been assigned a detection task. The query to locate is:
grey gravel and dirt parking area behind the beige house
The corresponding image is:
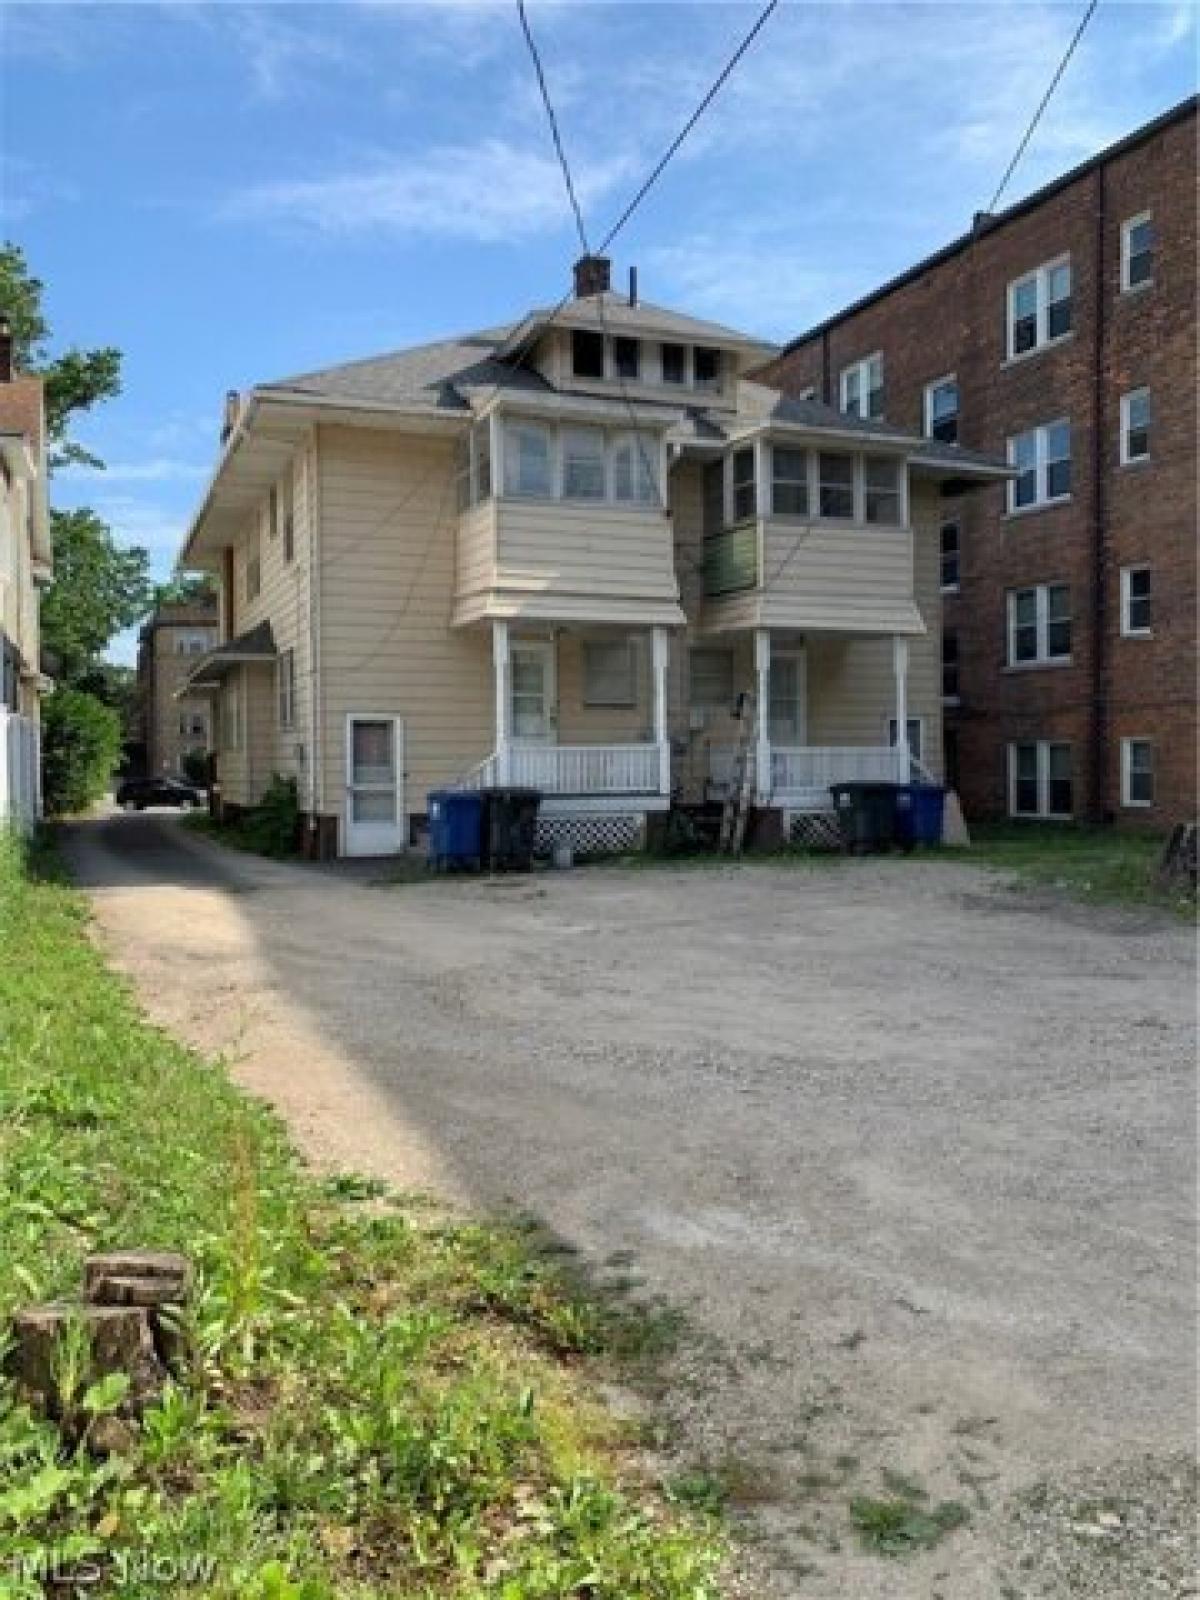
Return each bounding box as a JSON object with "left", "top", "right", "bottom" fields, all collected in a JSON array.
[{"left": 63, "top": 816, "right": 1195, "bottom": 1600}]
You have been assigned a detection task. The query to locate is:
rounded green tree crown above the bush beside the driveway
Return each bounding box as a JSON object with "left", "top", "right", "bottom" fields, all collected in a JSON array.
[{"left": 42, "top": 509, "right": 152, "bottom": 683}]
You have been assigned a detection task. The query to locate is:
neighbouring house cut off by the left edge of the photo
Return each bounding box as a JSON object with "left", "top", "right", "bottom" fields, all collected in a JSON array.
[{"left": 0, "top": 322, "right": 53, "bottom": 827}]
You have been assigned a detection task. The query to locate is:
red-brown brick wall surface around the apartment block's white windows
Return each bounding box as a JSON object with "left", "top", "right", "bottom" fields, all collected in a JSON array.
[{"left": 763, "top": 103, "right": 1197, "bottom": 827}]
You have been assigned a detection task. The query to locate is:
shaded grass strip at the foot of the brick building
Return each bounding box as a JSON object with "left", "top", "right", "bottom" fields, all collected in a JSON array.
[{"left": 946, "top": 822, "right": 1195, "bottom": 917}]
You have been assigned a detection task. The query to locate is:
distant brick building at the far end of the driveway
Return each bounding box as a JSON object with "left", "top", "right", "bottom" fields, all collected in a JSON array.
[{"left": 138, "top": 595, "right": 218, "bottom": 778}]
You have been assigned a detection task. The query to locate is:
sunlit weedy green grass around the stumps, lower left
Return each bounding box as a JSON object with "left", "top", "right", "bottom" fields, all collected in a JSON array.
[{"left": 0, "top": 842, "right": 722, "bottom": 1600}]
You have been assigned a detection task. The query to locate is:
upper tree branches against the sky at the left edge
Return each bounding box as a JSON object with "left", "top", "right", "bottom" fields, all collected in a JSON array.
[{"left": 0, "top": 243, "right": 122, "bottom": 467}]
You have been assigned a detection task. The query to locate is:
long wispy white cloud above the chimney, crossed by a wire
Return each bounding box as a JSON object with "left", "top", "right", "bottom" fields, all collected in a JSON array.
[{"left": 224, "top": 138, "right": 634, "bottom": 243}]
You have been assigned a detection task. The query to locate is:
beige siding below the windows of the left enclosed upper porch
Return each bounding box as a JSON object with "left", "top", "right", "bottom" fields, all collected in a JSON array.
[{"left": 454, "top": 499, "right": 680, "bottom": 624}]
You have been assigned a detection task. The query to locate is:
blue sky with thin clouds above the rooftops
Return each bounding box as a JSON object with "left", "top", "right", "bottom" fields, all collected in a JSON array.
[{"left": 0, "top": 0, "right": 1197, "bottom": 659}]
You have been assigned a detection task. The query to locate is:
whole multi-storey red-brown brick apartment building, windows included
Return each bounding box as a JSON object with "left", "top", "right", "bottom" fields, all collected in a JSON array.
[{"left": 763, "top": 98, "right": 1197, "bottom": 827}]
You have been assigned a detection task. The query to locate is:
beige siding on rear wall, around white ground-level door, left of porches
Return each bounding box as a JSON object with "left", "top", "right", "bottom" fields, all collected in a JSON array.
[{"left": 318, "top": 427, "right": 494, "bottom": 814}]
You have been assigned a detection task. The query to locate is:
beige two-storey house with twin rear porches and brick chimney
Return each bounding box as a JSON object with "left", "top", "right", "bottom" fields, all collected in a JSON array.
[{"left": 179, "top": 258, "right": 1008, "bottom": 854}]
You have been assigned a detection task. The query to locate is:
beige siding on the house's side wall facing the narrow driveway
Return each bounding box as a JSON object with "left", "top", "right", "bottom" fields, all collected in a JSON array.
[{"left": 213, "top": 443, "right": 318, "bottom": 811}]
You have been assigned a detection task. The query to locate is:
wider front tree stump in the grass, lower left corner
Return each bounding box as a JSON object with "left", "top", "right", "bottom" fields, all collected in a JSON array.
[{"left": 5, "top": 1301, "right": 165, "bottom": 1421}]
